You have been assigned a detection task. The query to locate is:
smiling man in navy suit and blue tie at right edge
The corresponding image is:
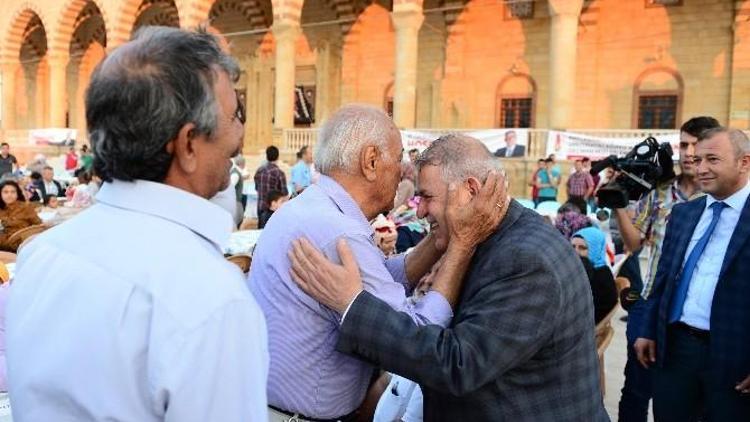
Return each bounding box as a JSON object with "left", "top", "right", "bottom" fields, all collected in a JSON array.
[{"left": 634, "top": 128, "right": 750, "bottom": 422}]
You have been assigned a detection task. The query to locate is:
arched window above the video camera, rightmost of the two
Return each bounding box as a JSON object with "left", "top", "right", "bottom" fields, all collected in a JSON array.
[{"left": 633, "top": 68, "right": 683, "bottom": 129}]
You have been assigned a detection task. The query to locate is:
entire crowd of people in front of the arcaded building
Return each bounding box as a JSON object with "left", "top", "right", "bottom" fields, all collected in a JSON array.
[{"left": 0, "top": 27, "right": 750, "bottom": 422}]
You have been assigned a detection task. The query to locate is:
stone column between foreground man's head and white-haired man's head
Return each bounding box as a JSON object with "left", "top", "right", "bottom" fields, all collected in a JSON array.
[{"left": 271, "top": 20, "right": 301, "bottom": 129}]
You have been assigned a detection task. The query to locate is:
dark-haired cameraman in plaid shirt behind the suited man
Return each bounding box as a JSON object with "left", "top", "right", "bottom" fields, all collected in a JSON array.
[{"left": 615, "top": 116, "right": 719, "bottom": 422}]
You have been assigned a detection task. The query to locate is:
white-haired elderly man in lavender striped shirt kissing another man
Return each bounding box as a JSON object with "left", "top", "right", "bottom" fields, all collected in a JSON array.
[{"left": 249, "top": 105, "right": 504, "bottom": 420}]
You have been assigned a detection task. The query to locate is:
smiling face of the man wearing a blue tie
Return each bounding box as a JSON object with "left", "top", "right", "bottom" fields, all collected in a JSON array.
[{"left": 694, "top": 132, "right": 750, "bottom": 200}]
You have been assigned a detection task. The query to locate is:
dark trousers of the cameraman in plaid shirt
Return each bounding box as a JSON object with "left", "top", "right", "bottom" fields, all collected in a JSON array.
[{"left": 619, "top": 299, "right": 651, "bottom": 422}]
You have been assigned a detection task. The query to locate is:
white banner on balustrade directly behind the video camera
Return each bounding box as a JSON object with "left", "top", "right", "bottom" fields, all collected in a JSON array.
[{"left": 547, "top": 130, "right": 680, "bottom": 160}]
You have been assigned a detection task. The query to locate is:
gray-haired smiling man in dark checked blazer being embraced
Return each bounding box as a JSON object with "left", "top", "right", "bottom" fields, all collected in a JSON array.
[{"left": 292, "top": 135, "right": 609, "bottom": 422}]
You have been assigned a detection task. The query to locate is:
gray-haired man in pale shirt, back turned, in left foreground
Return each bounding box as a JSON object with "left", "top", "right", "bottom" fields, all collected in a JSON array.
[{"left": 7, "top": 28, "right": 268, "bottom": 422}]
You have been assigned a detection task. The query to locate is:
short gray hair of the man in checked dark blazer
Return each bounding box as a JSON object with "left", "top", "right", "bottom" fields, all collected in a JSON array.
[{"left": 416, "top": 134, "right": 503, "bottom": 183}]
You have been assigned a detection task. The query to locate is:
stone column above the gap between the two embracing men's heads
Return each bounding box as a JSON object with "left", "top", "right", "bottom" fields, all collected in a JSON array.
[{"left": 391, "top": 3, "right": 424, "bottom": 128}]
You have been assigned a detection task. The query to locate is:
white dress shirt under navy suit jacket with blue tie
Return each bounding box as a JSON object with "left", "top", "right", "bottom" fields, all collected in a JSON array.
[{"left": 680, "top": 183, "right": 750, "bottom": 330}]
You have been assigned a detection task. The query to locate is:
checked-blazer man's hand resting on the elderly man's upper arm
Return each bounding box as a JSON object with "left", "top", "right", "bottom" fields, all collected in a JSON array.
[{"left": 288, "top": 238, "right": 363, "bottom": 314}]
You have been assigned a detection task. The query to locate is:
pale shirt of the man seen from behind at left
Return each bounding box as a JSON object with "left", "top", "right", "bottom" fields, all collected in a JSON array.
[{"left": 7, "top": 181, "right": 268, "bottom": 422}]
